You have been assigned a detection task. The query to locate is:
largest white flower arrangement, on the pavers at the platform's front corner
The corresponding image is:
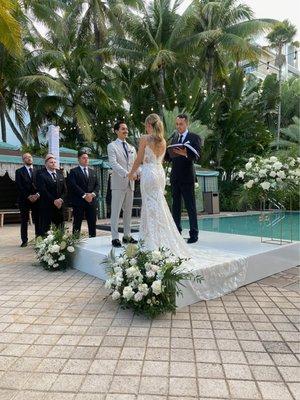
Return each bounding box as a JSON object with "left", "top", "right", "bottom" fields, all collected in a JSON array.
[{"left": 105, "top": 243, "right": 202, "bottom": 318}]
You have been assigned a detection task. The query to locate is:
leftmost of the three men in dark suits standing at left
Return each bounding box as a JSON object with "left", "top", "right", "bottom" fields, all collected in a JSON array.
[{"left": 16, "top": 153, "right": 40, "bottom": 247}]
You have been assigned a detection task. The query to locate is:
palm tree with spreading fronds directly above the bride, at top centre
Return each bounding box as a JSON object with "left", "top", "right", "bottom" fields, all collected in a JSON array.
[{"left": 110, "top": 0, "right": 195, "bottom": 115}]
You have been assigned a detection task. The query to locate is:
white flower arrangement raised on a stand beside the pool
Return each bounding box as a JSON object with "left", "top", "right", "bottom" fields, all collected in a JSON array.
[{"left": 237, "top": 156, "right": 300, "bottom": 197}]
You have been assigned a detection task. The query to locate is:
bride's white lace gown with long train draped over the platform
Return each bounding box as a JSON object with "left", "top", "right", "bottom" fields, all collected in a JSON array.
[{"left": 139, "top": 144, "right": 246, "bottom": 300}]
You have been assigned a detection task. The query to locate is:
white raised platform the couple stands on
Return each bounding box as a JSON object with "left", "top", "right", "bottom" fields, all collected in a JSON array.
[{"left": 73, "top": 231, "right": 300, "bottom": 307}]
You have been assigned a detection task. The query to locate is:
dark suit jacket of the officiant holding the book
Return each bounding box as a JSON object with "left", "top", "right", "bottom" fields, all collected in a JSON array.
[{"left": 165, "top": 131, "right": 201, "bottom": 183}]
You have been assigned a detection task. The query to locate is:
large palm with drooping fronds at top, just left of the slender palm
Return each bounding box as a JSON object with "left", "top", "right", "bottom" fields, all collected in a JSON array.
[{"left": 189, "top": 0, "right": 273, "bottom": 93}]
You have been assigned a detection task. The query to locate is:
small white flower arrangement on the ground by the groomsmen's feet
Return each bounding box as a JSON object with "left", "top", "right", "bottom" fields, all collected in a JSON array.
[{"left": 34, "top": 227, "right": 81, "bottom": 271}]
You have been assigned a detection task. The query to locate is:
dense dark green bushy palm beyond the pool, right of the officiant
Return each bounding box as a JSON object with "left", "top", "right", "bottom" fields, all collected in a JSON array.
[{"left": 203, "top": 68, "right": 272, "bottom": 177}]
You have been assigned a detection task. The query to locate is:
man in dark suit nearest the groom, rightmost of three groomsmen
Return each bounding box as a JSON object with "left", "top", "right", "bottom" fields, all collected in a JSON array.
[{"left": 68, "top": 151, "right": 99, "bottom": 237}]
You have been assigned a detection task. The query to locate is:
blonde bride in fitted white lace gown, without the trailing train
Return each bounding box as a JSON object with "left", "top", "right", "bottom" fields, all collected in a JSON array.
[{"left": 128, "top": 114, "right": 189, "bottom": 257}]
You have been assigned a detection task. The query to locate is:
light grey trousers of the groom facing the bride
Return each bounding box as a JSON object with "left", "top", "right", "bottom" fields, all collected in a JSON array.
[{"left": 110, "top": 185, "right": 133, "bottom": 240}]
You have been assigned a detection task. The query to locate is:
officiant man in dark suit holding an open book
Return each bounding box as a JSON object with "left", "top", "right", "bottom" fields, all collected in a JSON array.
[{"left": 166, "top": 114, "right": 201, "bottom": 243}]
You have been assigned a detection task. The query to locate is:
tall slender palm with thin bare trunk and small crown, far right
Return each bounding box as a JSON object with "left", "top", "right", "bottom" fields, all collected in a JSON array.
[{"left": 267, "top": 20, "right": 298, "bottom": 150}]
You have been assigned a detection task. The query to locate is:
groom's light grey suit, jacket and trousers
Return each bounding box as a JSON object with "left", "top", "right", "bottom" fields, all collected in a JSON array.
[{"left": 107, "top": 139, "right": 136, "bottom": 240}]
